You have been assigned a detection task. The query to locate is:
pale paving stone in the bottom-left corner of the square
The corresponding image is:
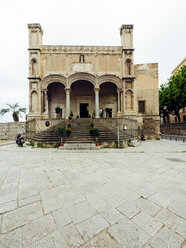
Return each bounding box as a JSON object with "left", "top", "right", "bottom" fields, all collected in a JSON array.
[{"left": 0, "top": 229, "right": 22, "bottom": 248}]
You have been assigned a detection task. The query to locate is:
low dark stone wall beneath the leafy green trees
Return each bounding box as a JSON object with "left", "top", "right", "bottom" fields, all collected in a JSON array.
[{"left": 160, "top": 122, "right": 186, "bottom": 136}]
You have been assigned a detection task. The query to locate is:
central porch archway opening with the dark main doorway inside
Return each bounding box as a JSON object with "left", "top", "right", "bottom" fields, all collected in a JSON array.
[{"left": 70, "top": 80, "right": 95, "bottom": 118}]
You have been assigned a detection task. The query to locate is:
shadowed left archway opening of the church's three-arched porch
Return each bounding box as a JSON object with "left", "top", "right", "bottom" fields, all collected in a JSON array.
[{"left": 47, "top": 82, "right": 66, "bottom": 118}]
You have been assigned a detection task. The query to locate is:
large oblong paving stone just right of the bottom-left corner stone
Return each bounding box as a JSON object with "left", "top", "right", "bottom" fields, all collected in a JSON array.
[{"left": 23, "top": 215, "right": 57, "bottom": 246}]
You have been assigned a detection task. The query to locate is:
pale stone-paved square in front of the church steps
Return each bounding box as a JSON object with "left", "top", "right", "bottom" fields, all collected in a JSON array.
[{"left": 0, "top": 140, "right": 186, "bottom": 248}]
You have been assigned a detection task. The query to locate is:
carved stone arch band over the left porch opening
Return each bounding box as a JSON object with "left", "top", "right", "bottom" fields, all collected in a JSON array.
[{"left": 41, "top": 74, "right": 67, "bottom": 90}]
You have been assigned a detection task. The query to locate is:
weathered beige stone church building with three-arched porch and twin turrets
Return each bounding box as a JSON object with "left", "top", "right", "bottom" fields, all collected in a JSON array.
[{"left": 28, "top": 24, "right": 159, "bottom": 138}]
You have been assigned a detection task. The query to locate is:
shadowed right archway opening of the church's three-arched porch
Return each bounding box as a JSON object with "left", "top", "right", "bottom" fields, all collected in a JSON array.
[{"left": 99, "top": 82, "right": 117, "bottom": 118}]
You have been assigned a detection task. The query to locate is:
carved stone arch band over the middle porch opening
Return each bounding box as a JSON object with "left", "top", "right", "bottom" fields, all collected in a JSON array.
[{"left": 68, "top": 72, "right": 96, "bottom": 88}]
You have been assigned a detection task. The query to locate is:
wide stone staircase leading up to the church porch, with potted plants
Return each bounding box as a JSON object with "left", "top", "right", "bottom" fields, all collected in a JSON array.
[{"left": 35, "top": 118, "right": 133, "bottom": 144}]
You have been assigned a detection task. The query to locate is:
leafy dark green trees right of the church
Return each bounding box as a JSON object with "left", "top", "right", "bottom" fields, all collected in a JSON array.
[{"left": 159, "top": 65, "right": 186, "bottom": 122}]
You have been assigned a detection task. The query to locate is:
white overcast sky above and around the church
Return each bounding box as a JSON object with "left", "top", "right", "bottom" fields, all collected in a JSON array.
[{"left": 0, "top": 0, "right": 186, "bottom": 122}]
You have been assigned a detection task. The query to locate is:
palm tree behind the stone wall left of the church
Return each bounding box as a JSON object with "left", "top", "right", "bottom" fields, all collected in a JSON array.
[{"left": 0, "top": 103, "right": 26, "bottom": 122}]
